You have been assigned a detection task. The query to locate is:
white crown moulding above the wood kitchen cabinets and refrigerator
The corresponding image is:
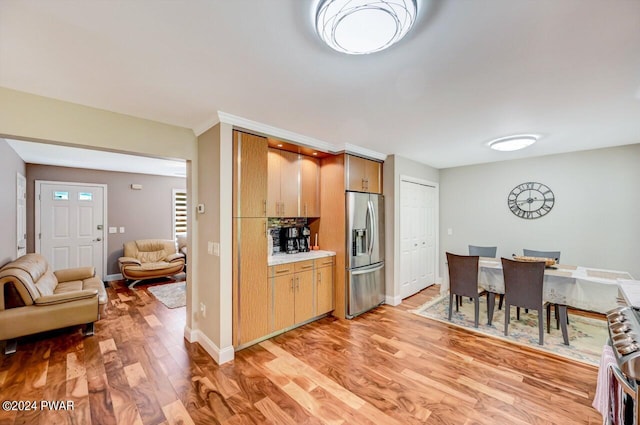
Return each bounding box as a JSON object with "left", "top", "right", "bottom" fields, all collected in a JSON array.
[{"left": 218, "top": 111, "right": 387, "bottom": 161}]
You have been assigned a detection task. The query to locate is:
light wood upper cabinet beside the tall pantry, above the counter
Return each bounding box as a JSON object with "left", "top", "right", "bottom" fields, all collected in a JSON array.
[{"left": 266, "top": 148, "right": 299, "bottom": 217}]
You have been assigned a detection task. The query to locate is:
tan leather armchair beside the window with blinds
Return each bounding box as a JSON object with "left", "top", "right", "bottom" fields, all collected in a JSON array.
[{"left": 118, "top": 239, "right": 185, "bottom": 288}]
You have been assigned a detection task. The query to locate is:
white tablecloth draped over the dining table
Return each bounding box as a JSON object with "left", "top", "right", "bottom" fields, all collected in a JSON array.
[{"left": 442, "top": 258, "right": 633, "bottom": 313}]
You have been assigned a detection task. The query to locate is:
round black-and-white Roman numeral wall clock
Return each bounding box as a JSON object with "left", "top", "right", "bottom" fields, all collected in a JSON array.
[{"left": 507, "top": 182, "right": 555, "bottom": 219}]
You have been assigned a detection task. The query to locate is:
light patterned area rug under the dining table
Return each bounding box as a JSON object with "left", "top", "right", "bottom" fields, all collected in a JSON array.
[{"left": 411, "top": 295, "right": 609, "bottom": 366}]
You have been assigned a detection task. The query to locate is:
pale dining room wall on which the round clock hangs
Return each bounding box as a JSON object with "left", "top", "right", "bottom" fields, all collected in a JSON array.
[{"left": 440, "top": 144, "right": 640, "bottom": 279}]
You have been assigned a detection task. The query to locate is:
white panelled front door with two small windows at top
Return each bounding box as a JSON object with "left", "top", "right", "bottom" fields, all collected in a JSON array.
[{"left": 36, "top": 181, "right": 106, "bottom": 278}]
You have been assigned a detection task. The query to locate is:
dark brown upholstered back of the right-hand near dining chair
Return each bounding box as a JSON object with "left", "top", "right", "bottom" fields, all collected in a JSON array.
[{"left": 502, "top": 258, "right": 544, "bottom": 310}]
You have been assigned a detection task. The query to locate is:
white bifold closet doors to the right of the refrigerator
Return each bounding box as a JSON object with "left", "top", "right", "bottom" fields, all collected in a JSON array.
[{"left": 400, "top": 180, "right": 436, "bottom": 298}]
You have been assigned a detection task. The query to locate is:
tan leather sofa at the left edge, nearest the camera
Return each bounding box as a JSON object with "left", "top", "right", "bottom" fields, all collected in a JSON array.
[{"left": 0, "top": 254, "right": 107, "bottom": 354}]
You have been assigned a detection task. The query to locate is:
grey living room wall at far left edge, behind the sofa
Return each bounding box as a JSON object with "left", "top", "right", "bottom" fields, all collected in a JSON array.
[{"left": 0, "top": 139, "right": 26, "bottom": 267}]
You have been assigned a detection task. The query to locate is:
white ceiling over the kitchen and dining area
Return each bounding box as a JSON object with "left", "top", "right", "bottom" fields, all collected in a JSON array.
[{"left": 0, "top": 0, "right": 640, "bottom": 168}]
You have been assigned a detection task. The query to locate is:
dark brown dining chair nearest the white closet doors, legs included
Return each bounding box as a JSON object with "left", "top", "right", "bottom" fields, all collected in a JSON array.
[{"left": 447, "top": 252, "right": 495, "bottom": 328}]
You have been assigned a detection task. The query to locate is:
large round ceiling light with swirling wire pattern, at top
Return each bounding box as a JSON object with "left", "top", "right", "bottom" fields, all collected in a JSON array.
[{"left": 316, "top": 0, "right": 418, "bottom": 55}]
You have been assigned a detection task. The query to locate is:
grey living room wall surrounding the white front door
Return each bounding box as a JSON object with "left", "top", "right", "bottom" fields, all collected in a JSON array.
[{"left": 27, "top": 164, "right": 187, "bottom": 274}]
